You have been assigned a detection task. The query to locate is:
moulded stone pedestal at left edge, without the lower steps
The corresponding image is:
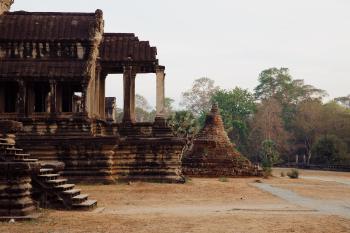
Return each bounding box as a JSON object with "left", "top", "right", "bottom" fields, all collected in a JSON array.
[{"left": 0, "top": 121, "right": 40, "bottom": 219}]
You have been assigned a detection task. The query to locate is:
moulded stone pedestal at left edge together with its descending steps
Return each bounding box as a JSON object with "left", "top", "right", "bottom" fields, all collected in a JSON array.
[{"left": 0, "top": 120, "right": 97, "bottom": 220}]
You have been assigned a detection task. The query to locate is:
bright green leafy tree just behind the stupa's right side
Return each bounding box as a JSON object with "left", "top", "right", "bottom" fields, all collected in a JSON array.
[{"left": 212, "top": 87, "right": 256, "bottom": 154}]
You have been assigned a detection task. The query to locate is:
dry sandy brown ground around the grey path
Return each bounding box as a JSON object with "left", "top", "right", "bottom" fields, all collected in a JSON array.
[{"left": 0, "top": 170, "right": 350, "bottom": 233}]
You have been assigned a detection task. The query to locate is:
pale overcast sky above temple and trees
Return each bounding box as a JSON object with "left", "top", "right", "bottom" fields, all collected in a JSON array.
[{"left": 12, "top": 0, "right": 350, "bottom": 109}]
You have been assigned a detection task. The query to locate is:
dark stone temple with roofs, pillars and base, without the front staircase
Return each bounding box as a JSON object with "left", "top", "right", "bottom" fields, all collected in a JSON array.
[{"left": 0, "top": 2, "right": 184, "bottom": 182}]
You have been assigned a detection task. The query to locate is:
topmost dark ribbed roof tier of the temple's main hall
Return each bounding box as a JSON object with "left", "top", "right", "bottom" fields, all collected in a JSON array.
[{"left": 0, "top": 11, "right": 102, "bottom": 41}]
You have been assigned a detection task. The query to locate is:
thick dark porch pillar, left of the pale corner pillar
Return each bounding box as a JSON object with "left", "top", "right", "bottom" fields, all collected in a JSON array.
[{"left": 123, "top": 66, "right": 136, "bottom": 123}]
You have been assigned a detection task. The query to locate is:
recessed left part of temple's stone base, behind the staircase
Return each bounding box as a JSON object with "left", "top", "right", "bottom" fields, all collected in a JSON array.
[{"left": 18, "top": 119, "right": 117, "bottom": 183}]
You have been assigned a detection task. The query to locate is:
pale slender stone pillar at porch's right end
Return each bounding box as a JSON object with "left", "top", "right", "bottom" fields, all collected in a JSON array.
[{"left": 156, "top": 66, "right": 165, "bottom": 118}]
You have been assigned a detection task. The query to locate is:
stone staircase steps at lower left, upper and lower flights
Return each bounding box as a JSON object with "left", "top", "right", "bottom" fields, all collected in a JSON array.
[{"left": 0, "top": 138, "right": 97, "bottom": 210}]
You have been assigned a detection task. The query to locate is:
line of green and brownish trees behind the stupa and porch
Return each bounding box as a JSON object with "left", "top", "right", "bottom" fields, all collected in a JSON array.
[{"left": 118, "top": 68, "right": 350, "bottom": 166}]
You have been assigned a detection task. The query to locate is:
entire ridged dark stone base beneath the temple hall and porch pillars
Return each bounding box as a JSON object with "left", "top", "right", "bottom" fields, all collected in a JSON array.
[{"left": 18, "top": 119, "right": 184, "bottom": 184}]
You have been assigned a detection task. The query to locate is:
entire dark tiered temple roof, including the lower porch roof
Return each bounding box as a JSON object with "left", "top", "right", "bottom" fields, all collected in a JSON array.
[{"left": 0, "top": 10, "right": 158, "bottom": 79}]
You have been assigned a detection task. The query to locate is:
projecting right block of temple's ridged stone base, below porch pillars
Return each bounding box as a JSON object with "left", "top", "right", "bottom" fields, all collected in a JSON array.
[{"left": 114, "top": 138, "right": 184, "bottom": 183}]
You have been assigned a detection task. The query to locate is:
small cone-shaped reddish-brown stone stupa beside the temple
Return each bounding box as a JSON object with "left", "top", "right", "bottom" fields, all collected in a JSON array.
[{"left": 182, "top": 104, "right": 259, "bottom": 177}]
